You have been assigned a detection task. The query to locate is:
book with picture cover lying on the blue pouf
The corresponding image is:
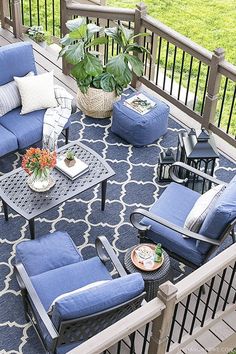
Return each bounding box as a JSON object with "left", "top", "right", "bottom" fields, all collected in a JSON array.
[{"left": 124, "top": 93, "right": 156, "bottom": 115}]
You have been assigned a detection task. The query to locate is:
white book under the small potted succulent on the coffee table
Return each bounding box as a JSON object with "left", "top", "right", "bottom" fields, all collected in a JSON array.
[{"left": 56, "top": 155, "right": 89, "bottom": 180}]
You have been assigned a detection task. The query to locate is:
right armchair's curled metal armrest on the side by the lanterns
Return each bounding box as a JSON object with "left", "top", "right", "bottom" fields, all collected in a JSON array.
[{"left": 170, "top": 162, "right": 227, "bottom": 184}]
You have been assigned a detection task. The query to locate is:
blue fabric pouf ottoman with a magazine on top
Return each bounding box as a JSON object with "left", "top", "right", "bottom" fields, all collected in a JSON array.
[{"left": 111, "top": 92, "right": 170, "bottom": 147}]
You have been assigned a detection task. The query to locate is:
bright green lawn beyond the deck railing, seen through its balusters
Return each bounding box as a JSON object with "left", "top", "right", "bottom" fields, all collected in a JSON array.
[{"left": 19, "top": 0, "right": 236, "bottom": 135}]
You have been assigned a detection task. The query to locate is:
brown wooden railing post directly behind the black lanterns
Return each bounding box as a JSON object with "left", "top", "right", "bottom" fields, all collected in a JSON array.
[{"left": 202, "top": 48, "right": 225, "bottom": 129}]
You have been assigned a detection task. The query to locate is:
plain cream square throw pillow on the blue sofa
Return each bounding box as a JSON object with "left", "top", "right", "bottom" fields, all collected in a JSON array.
[{"left": 14, "top": 71, "right": 57, "bottom": 114}]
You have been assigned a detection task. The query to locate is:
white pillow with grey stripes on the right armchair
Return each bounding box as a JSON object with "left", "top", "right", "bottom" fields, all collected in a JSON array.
[{"left": 183, "top": 184, "right": 226, "bottom": 237}]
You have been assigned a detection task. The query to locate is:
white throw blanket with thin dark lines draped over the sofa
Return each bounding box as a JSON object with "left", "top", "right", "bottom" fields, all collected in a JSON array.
[{"left": 43, "top": 85, "right": 73, "bottom": 151}]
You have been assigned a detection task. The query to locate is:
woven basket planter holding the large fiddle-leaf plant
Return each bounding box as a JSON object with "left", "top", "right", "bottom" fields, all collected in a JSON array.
[{"left": 77, "top": 87, "right": 119, "bottom": 118}]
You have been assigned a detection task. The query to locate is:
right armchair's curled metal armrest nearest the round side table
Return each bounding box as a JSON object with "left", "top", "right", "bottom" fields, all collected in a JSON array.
[{"left": 130, "top": 209, "right": 220, "bottom": 246}]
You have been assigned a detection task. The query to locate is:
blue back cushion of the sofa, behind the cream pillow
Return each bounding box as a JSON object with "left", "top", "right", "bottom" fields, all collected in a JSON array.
[{"left": 0, "top": 42, "right": 37, "bottom": 85}]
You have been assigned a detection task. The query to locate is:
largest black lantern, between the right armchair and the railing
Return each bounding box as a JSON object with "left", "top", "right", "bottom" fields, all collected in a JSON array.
[{"left": 178, "top": 129, "right": 219, "bottom": 176}]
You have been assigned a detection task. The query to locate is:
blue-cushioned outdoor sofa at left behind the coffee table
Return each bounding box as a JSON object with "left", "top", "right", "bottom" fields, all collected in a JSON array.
[{"left": 0, "top": 42, "right": 73, "bottom": 157}]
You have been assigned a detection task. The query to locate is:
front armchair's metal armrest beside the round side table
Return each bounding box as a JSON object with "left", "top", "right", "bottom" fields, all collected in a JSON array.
[{"left": 95, "top": 236, "right": 127, "bottom": 277}]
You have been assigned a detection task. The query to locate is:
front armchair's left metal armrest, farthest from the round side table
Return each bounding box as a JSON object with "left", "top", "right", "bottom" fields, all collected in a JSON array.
[{"left": 15, "top": 263, "right": 59, "bottom": 340}]
